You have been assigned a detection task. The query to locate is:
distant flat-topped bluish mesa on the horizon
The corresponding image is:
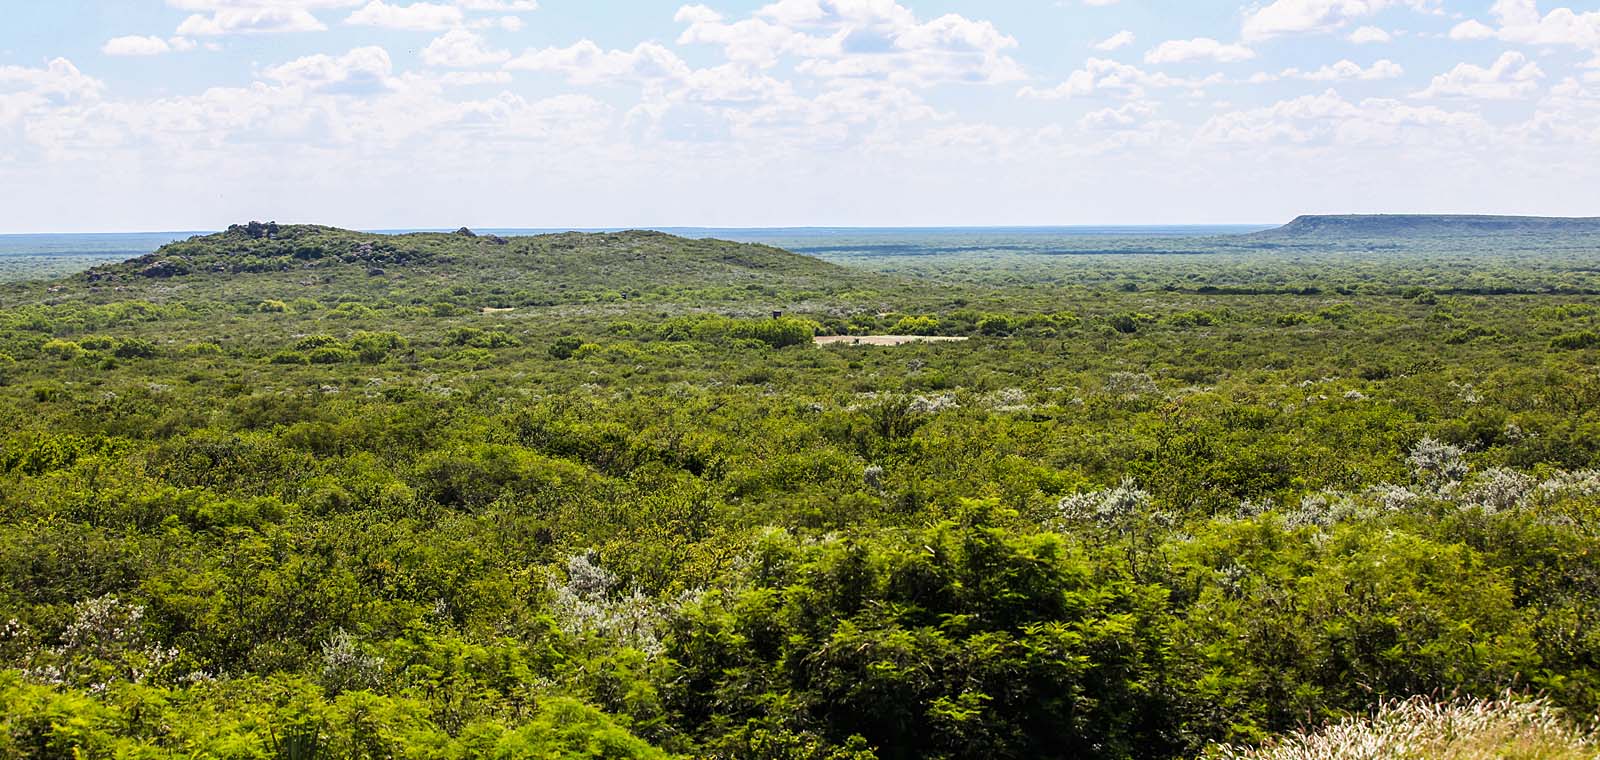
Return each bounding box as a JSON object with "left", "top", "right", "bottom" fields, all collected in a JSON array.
[{"left": 1256, "top": 214, "right": 1600, "bottom": 237}]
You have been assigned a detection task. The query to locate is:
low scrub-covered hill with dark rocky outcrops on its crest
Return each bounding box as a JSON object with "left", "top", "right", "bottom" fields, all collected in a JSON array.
[{"left": 72, "top": 222, "right": 870, "bottom": 306}]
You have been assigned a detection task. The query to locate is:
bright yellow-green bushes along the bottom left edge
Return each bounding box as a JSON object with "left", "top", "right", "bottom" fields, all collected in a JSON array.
[{"left": 0, "top": 672, "right": 669, "bottom": 760}]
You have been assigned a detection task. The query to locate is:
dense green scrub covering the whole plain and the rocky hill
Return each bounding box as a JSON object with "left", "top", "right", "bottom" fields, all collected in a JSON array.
[{"left": 0, "top": 222, "right": 1600, "bottom": 760}]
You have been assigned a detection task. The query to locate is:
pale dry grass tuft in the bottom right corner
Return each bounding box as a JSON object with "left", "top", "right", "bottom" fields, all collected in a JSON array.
[{"left": 1208, "top": 696, "right": 1600, "bottom": 760}]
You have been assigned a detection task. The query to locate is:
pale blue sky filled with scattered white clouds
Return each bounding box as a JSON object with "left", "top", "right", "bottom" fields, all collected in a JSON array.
[{"left": 0, "top": 0, "right": 1600, "bottom": 232}]
